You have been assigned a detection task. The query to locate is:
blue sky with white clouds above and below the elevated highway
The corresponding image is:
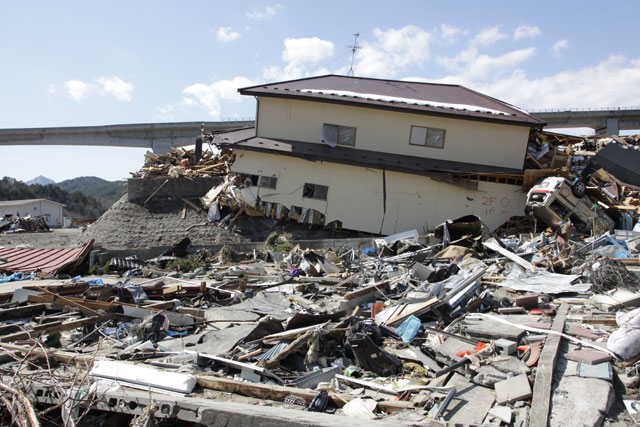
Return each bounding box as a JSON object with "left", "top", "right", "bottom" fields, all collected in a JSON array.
[{"left": 0, "top": 0, "right": 640, "bottom": 181}]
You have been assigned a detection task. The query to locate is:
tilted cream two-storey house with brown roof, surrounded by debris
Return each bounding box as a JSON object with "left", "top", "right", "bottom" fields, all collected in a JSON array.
[{"left": 222, "top": 75, "right": 544, "bottom": 234}]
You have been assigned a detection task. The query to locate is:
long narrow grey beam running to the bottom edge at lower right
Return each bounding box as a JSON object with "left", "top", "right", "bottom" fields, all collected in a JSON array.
[{"left": 529, "top": 304, "right": 569, "bottom": 427}]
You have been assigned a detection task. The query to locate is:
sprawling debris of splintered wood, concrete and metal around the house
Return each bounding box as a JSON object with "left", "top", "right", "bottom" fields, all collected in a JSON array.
[{"left": 0, "top": 134, "right": 640, "bottom": 427}]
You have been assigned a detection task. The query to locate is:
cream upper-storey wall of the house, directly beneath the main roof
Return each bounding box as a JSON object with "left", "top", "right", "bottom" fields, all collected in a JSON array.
[{"left": 257, "top": 97, "right": 529, "bottom": 169}]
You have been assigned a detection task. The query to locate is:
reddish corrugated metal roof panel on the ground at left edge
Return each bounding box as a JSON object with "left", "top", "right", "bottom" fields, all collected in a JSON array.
[{"left": 0, "top": 240, "right": 93, "bottom": 273}]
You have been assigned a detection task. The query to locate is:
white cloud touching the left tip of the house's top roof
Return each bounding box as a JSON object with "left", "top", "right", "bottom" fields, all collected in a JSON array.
[{"left": 181, "top": 77, "right": 257, "bottom": 119}]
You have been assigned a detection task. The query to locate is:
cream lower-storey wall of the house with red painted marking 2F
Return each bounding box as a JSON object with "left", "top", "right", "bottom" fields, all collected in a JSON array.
[{"left": 232, "top": 148, "right": 526, "bottom": 234}]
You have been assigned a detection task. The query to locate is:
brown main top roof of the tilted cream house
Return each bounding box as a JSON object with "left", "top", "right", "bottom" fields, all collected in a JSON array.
[{"left": 239, "top": 75, "right": 544, "bottom": 127}]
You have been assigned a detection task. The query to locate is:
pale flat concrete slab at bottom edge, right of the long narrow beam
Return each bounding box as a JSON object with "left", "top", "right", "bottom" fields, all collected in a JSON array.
[{"left": 549, "top": 376, "right": 615, "bottom": 427}]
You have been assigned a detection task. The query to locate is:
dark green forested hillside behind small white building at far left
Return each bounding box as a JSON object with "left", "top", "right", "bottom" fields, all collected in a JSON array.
[{"left": 0, "top": 177, "right": 106, "bottom": 219}]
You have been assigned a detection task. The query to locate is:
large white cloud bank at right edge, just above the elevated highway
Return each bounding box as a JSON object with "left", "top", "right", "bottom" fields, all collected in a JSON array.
[{"left": 474, "top": 56, "right": 640, "bottom": 108}]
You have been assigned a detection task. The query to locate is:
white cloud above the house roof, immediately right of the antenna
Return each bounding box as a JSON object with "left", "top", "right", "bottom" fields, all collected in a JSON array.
[{"left": 354, "top": 25, "right": 431, "bottom": 77}]
